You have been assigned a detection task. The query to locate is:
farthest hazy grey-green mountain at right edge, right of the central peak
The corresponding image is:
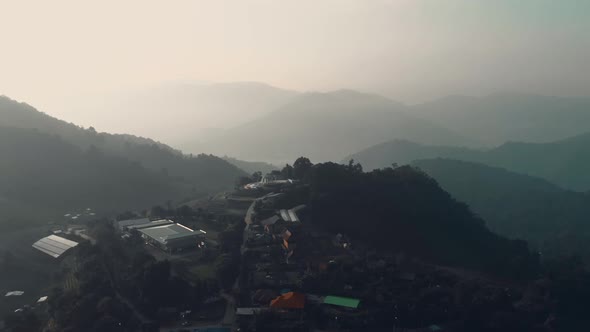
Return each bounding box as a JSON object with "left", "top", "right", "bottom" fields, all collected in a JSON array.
[{"left": 412, "top": 93, "right": 590, "bottom": 146}]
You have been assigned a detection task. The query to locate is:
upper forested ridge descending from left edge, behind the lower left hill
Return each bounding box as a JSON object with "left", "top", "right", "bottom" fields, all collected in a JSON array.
[{"left": 0, "top": 97, "right": 244, "bottom": 192}]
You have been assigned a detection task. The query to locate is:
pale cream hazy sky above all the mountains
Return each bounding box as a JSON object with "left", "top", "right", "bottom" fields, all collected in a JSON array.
[{"left": 0, "top": 0, "right": 590, "bottom": 127}]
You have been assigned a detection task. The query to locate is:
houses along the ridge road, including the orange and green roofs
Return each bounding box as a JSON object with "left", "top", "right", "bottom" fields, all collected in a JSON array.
[{"left": 236, "top": 194, "right": 364, "bottom": 331}]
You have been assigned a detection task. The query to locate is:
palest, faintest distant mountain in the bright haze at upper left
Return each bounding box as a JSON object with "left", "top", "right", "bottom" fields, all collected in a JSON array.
[{"left": 63, "top": 82, "right": 297, "bottom": 144}]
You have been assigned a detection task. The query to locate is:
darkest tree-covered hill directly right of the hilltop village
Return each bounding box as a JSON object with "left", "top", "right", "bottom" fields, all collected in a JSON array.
[{"left": 310, "top": 163, "right": 537, "bottom": 277}]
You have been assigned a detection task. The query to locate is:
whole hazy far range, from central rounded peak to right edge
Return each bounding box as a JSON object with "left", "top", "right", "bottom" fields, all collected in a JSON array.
[{"left": 173, "top": 90, "right": 590, "bottom": 164}]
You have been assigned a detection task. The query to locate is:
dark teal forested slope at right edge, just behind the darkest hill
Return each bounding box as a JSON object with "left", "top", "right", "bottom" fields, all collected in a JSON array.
[{"left": 413, "top": 159, "right": 590, "bottom": 259}]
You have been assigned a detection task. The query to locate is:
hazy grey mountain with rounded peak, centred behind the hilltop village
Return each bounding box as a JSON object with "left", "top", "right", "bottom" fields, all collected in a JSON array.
[{"left": 184, "top": 90, "right": 474, "bottom": 164}]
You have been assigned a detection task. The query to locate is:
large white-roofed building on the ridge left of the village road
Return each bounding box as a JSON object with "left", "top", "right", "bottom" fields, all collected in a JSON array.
[{"left": 137, "top": 223, "right": 206, "bottom": 252}]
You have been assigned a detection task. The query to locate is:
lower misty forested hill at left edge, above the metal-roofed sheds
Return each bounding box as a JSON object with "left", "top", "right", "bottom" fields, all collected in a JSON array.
[{"left": 0, "top": 127, "right": 194, "bottom": 223}]
